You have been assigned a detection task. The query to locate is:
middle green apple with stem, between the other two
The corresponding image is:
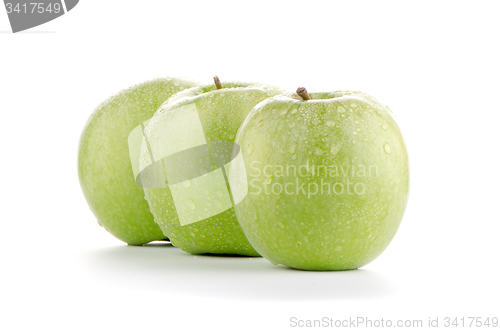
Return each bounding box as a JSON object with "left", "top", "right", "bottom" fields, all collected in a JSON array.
[{"left": 140, "top": 78, "right": 283, "bottom": 256}]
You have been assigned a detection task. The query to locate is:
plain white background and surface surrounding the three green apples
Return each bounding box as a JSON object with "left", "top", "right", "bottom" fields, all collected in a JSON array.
[{"left": 0, "top": 0, "right": 500, "bottom": 330}]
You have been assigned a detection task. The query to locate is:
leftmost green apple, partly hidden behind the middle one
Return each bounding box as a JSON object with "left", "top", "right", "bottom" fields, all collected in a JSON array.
[{"left": 78, "top": 77, "right": 197, "bottom": 245}]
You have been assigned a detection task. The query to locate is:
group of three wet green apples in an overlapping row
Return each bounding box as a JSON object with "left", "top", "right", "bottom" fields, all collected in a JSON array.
[{"left": 78, "top": 77, "right": 409, "bottom": 270}]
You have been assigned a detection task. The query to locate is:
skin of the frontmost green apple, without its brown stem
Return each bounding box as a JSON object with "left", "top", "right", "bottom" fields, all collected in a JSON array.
[{"left": 235, "top": 91, "right": 409, "bottom": 270}]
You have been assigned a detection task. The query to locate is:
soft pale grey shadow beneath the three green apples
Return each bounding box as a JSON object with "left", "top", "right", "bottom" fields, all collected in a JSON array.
[{"left": 84, "top": 243, "right": 396, "bottom": 301}]
